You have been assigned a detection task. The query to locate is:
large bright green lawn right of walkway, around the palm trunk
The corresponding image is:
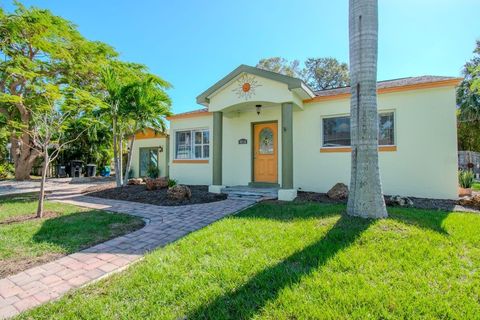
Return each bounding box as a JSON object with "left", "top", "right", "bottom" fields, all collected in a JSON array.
[{"left": 20, "top": 203, "right": 480, "bottom": 319}]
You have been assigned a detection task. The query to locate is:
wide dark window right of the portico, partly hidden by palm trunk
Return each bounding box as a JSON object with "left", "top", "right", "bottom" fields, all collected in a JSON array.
[{"left": 323, "top": 112, "right": 395, "bottom": 147}]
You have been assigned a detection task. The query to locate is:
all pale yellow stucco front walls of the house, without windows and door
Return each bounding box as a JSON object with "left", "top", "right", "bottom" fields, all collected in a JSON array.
[{"left": 170, "top": 86, "right": 457, "bottom": 199}]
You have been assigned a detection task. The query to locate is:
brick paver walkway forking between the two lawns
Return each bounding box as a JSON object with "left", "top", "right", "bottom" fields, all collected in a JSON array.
[{"left": 0, "top": 196, "right": 253, "bottom": 318}]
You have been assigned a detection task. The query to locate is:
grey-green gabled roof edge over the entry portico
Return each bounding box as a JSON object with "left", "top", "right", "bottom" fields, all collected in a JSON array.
[{"left": 197, "top": 64, "right": 315, "bottom": 106}]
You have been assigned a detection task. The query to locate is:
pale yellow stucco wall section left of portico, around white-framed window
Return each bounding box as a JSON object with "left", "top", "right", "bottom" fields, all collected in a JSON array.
[{"left": 170, "top": 114, "right": 213, "bottom": 185}]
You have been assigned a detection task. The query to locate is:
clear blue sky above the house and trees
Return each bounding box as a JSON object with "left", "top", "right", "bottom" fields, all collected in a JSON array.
[{"left": 0, "top": 0, "right": 480, "bottom": 113}]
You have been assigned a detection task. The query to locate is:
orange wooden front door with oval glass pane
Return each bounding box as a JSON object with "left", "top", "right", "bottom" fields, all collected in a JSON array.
[{"left": 253, "top": 122, "right": 278, "bottom": 183}]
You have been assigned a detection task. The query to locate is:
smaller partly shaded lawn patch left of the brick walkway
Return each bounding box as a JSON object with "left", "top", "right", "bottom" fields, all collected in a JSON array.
[{"left": 0, "top": 194, "right": 143, "bottom": 278}]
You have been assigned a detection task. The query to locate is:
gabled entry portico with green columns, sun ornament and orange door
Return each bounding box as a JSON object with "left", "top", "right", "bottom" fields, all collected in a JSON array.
[{"left": 197, "top": 65, "right": 314, "bottom": 200}]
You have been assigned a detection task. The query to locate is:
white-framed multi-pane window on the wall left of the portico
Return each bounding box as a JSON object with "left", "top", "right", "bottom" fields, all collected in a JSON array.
[{"left": 175, "top": 130, "right": 210, "bottom": 159}]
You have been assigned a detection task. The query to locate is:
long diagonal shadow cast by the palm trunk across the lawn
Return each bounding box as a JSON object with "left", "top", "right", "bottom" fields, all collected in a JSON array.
[{"left": 188, "top": 211, "right": 374, "bottom": 319}]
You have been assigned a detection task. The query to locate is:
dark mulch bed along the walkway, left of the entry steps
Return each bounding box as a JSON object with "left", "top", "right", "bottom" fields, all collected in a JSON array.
[{"left": 88, "top": 184, "right": 227, "bottom": 206}]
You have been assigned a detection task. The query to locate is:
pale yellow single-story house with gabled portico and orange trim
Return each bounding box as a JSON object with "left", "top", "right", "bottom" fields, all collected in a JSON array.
[{"left": 163, "top": 65, "right": 460, "bottom": 200}]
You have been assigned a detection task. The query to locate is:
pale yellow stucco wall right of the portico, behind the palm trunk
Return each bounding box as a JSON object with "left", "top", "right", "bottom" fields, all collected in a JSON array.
[{"left": 293, "top": 87, "right": 457, "bottom": 199}]
